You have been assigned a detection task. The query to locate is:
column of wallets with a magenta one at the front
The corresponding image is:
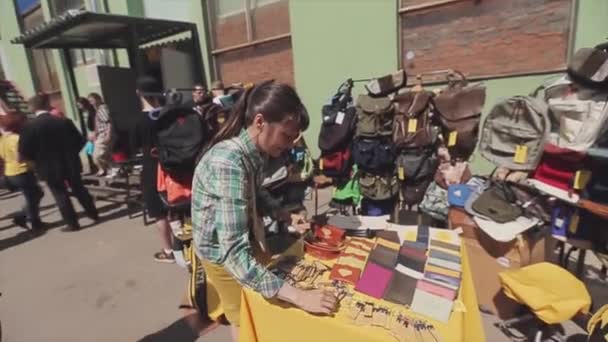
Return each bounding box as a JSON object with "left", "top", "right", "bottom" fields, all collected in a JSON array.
[{"left": 355, "top": 238, "right": 399, "bottom": 299}]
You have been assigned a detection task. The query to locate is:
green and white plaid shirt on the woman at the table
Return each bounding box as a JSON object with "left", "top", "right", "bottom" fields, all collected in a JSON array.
[{"left": 192, "top": 130, "right": 283, "bottom": 298}]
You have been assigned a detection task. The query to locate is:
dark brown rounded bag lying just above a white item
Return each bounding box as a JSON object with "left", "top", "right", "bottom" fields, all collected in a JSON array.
[{"left": 473, "top": 183, "right": 522, "bottom": 223}]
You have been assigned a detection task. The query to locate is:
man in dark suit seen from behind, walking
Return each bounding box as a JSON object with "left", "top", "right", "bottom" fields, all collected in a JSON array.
[{"left": 19, "top": 95, "right": 99, "bottom": 231}]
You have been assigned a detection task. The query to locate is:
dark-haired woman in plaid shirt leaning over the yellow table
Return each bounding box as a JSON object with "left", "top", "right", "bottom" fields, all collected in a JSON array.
[{"left": 192, "top": 82, "right": 336, "bottom": 340}]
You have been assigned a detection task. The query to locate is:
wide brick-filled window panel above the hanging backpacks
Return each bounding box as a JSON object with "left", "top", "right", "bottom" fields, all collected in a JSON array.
[{"left": 401, "top": 0, "right": 571, "bottom": 76}]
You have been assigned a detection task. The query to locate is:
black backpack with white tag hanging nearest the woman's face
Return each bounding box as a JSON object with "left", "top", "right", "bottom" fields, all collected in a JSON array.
[{"left": 319, "top": 79, "right": 357, "bottom": 152}]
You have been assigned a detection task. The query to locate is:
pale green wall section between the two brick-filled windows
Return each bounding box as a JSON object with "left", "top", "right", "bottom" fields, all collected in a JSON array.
[{"left": 289, "top": 0, "right": 398, "bottom": 156}]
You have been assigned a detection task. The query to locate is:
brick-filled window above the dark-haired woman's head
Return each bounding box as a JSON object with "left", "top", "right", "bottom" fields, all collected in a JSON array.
[{"left": 213, "top": 1, "right": 294, "bottom": 84}]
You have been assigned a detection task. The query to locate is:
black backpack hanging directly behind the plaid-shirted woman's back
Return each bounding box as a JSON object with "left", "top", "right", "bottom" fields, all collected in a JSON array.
[{"left": 154, "top": 105, "right": 208, "bottom": 175}]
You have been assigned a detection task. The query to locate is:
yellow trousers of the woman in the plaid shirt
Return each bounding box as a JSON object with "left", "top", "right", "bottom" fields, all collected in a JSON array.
[{"left": 201, "top": 259, "right": 242, "bottom": 327}]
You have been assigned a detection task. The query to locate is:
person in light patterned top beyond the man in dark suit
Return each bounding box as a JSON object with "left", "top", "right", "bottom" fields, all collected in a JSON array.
[{"left": 87, "top": 93, "right": 113, "bottom": 176}]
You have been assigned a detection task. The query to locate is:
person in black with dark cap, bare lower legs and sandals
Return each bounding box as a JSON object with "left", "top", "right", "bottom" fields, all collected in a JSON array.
[{"left": 133, "top": 76, "right": 175, "bottom": 263}]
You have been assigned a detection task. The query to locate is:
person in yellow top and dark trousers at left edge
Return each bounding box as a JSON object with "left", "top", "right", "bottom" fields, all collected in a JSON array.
[{"left": 0, "top": 112, "right": 44, "bottom": 232}]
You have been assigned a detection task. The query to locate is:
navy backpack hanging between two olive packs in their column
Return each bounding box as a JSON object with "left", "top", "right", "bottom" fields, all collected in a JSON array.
[{"left": 353, "top": 138, "right": 395, "bottom": 174}]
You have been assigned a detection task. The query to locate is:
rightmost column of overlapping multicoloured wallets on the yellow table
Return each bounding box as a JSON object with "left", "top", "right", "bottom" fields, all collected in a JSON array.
[{"left": 411, "top": 230, "right": 462, "bottom": 322}]
